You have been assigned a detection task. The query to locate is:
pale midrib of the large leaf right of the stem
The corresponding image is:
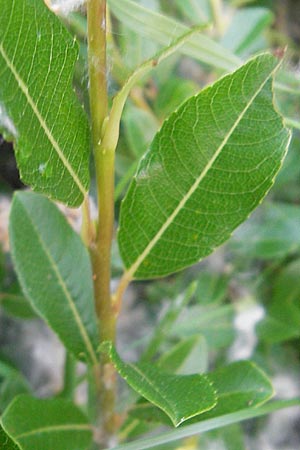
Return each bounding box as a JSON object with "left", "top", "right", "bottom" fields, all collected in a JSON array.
[{"left": 125, "top": 61, "right": 281, "bottom": 279}]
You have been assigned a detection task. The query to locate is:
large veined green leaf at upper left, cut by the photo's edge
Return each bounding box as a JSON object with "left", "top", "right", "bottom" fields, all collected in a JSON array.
[{"left": 0, "top": 0, "right": 90, "bottom": 206}]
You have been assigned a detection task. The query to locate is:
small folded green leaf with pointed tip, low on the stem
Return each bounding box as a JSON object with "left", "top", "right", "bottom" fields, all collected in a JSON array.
[{"left": 100, "top": 342, "right": 216, "bottom": 426}]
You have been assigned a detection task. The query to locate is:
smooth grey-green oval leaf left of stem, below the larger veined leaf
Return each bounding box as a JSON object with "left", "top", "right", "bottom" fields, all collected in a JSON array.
[{"left": 9, "top": 192, "right": 98, "bottom": 364}]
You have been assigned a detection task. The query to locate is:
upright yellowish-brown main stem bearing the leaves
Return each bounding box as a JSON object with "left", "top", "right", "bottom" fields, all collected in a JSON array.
[{"left": 87, "top": 0, "right": 116, "bottom": 446}]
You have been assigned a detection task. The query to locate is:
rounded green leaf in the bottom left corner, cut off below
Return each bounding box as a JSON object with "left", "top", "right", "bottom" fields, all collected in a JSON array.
[{"left": 1, "top": 395, "right": 92, "bottom": 450}]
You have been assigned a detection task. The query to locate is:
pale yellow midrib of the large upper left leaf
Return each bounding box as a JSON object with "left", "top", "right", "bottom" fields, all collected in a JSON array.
[{"left": 0, "top": 43, "right": 86, "bottom": 195}]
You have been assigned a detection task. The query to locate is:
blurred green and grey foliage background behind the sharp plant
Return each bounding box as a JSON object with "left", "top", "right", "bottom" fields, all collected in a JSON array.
[{"left": 0, "top": 0, "right": 300, "bottom": 450}]
